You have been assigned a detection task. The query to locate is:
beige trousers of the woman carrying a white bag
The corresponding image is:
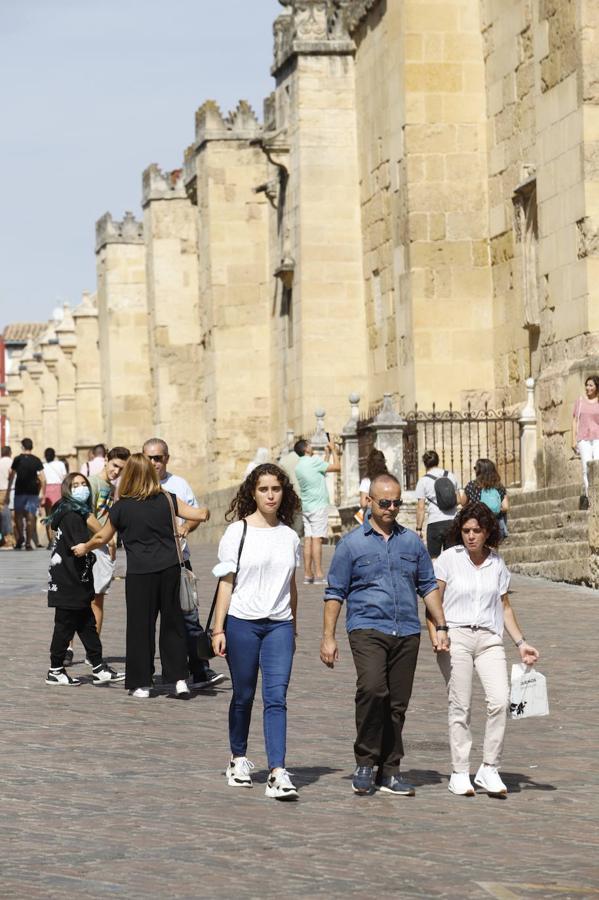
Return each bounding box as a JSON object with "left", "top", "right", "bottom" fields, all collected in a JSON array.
[{"left": 437, "top": 628, "right": 509, "bottom": 772}]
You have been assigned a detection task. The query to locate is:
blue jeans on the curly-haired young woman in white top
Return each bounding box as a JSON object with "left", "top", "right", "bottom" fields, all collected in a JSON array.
[{"left": 225, "top": 616, "right": 295, "bottom": 769}]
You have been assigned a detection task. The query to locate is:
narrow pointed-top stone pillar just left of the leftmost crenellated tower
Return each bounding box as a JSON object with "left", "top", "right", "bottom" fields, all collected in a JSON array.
[{"left": 73, "top": 291, "right": 104, "bottom": 463}]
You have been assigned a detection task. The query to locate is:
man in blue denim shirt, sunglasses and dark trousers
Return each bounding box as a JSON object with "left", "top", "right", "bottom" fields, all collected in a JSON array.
[{"left": 320, "top": 475, "right": 449, "bottom": 796}]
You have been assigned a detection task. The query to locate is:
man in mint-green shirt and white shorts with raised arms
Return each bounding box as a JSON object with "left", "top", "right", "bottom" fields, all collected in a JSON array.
[{"left": 293, "top": 440, "right": 341, "bottom": 584}]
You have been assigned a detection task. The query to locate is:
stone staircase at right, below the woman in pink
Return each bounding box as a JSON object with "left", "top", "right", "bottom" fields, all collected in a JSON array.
[{"left": 500, "top": 484, "right": 592, "bottom": 584}]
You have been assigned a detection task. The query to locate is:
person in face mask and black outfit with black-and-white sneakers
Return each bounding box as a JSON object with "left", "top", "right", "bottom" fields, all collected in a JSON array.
[{"left": 45, "top": 472, "right": 125, "bottom": 686}]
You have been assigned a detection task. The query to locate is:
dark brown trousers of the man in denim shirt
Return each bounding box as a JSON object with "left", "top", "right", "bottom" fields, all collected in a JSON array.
[{"left": 349, "top": 628, "right": 420, "bottom": 778}]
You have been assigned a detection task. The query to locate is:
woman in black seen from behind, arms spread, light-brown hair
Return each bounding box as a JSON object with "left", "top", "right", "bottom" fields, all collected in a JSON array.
[{"left": 73, "top": 453, "right": 209, "bottom": 697}]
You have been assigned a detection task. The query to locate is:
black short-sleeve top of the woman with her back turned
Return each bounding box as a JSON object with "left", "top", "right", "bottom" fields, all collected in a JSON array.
[{"left": 109, "top": 491, "right": 179, "bottom": 575}]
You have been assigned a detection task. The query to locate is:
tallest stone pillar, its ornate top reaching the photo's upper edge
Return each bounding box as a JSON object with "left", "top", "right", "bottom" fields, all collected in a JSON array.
[{"left": 270, "top": 0, "right": 368, "bottom": 442}]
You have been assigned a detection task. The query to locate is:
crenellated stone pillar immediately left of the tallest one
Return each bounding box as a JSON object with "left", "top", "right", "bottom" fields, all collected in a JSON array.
[{"left": 185, "top": 101, "right": 273, "bottom": 490}]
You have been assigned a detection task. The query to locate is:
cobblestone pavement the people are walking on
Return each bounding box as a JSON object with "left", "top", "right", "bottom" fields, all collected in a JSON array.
[{"left": 0, "top": 547, "right": 599, "bottom": 900}]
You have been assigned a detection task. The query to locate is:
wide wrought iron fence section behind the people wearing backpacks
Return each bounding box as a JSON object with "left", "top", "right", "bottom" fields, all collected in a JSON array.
[{"left": 403, "top": 403, "right": 520, "bottom": 490}]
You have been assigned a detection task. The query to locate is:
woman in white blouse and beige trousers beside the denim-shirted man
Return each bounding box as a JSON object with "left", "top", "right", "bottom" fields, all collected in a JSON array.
[{"left": 428, "top": 502, "right": 539, "bottom": 796}]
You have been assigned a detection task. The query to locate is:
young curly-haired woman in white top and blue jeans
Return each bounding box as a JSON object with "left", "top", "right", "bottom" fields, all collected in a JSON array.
[{"left": 212, "top": 463, "right": 300, "bottom": 800}]
